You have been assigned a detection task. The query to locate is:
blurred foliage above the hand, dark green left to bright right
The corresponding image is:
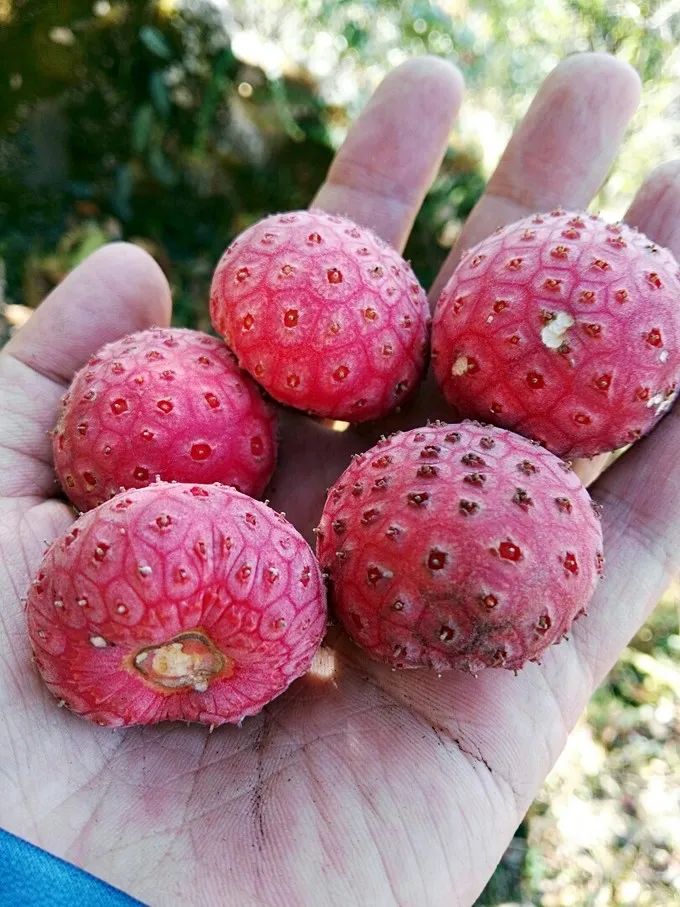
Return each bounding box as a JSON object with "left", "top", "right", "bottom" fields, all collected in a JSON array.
[{"left": 0, "top": 0, "right": 680, "bottom": 326}]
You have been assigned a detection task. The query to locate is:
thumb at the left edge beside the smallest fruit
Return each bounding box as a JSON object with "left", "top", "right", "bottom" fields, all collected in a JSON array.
[{"left": 0, "top": 243, "right": 171, "bottom": 496}]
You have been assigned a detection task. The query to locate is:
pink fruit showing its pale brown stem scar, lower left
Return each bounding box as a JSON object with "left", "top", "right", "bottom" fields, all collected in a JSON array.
[{"left": 27, "top": 483, "right": 326, "bottom": 726}]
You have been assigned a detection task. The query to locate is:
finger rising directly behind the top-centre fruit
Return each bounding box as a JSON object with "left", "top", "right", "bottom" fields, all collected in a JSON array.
[{"left": 313, "top": 57, "right": 463, "bottom": 251}]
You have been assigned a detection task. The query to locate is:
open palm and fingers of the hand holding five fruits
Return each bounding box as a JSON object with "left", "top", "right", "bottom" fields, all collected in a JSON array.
[{"left": 0, "top": 55, "right": 680, "bottom": 907}]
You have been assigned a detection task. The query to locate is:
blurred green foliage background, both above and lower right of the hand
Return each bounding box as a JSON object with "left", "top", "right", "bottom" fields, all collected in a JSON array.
[{"left": 0, "top": 0, "right": 680, "bottom": 907}]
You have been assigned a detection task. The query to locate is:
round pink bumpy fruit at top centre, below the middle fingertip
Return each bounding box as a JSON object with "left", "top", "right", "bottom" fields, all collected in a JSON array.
[{"left": 210, "top": 211, "right": 430, "bottom": 422}]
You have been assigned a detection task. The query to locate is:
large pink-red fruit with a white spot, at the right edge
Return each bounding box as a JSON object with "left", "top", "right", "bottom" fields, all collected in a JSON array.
[{"left": 432, "top": 210, "right": 680, "bottom": 457}]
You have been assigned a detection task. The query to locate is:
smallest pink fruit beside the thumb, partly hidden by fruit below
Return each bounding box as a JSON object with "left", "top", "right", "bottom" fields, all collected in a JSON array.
[{"left": 53, "top": 328, "right": 276, "bottom": 510}]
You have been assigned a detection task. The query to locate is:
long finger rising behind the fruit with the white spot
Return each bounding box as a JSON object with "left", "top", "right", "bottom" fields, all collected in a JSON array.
[{"left": 431, "top": 54, "right": 640, "bottom": 300}]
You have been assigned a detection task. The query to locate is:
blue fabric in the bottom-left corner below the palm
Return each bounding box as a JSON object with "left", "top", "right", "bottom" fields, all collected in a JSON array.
[{"left": 0, "top": 829, "right": 141, "bottom": 907}]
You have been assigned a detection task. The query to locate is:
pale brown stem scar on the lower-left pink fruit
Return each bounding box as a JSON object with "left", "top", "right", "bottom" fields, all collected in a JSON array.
[{"left": 132, "top": 630, "right": 234, "bottom": 693}]
